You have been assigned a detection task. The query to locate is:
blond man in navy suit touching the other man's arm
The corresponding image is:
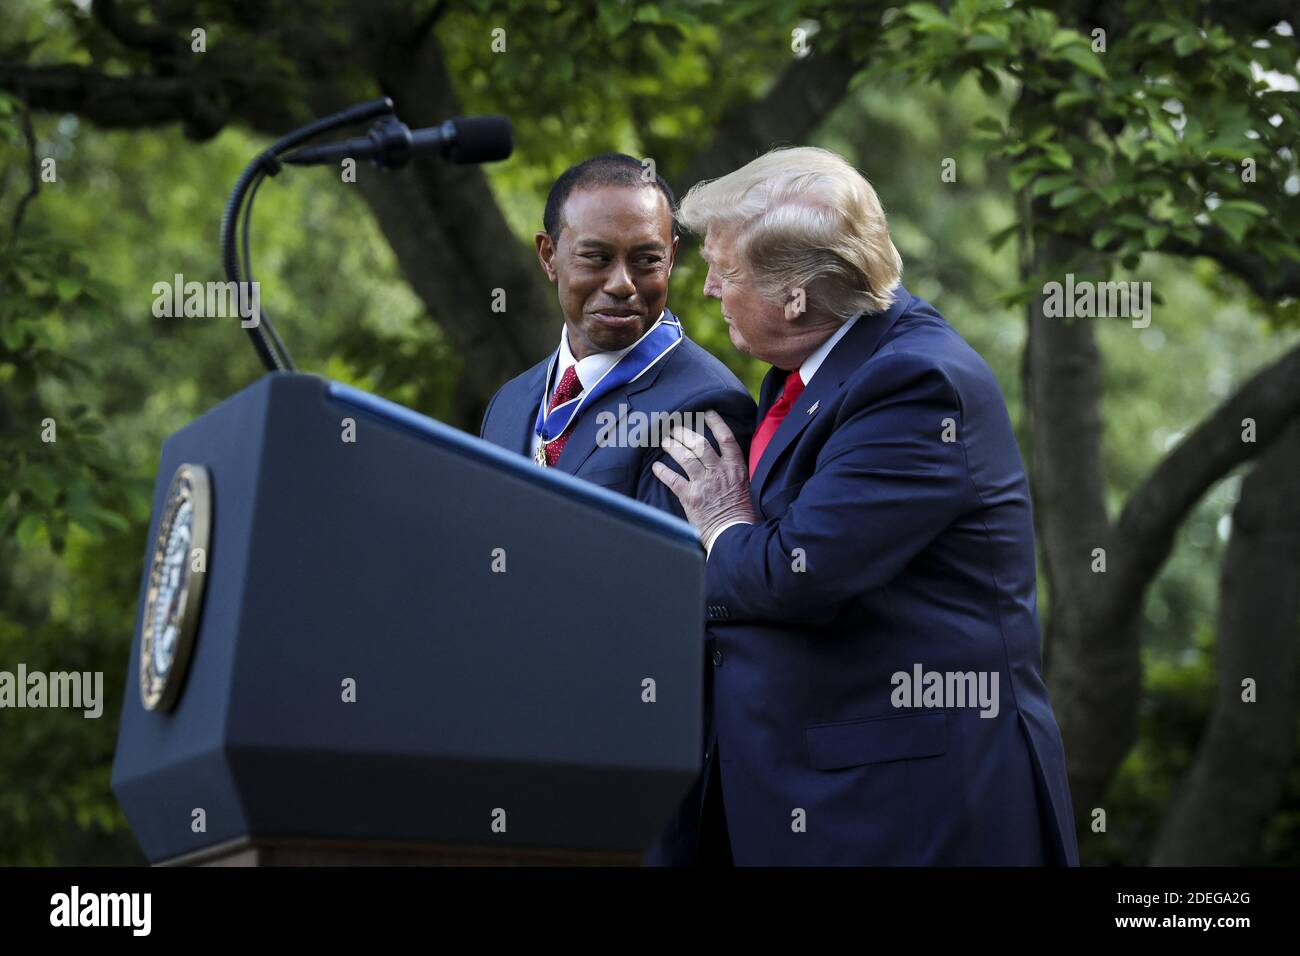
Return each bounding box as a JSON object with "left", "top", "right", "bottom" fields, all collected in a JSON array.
[{"left": 654, "top": 148, "right": 1078, "bottom": 866}]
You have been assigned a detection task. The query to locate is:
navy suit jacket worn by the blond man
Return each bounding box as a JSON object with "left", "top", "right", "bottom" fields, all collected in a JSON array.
[{"left": 706, "top": 286, "right": 1078, "bottom": 865}]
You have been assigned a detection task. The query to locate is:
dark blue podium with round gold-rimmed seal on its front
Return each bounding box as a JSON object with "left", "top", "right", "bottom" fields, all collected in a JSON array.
[{"left": 112, "top": 373, "right": 705, "bottom": 865}]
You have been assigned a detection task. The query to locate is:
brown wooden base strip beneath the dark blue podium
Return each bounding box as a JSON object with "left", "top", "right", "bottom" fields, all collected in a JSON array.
[{"left": 156, "top": 836, "right": 642, "bottom": 866}]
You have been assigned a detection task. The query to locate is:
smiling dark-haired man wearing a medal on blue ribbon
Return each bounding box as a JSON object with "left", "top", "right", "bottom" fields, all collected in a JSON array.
[{"left": 481, "top": 153, "right": 757, "bottom": 865}]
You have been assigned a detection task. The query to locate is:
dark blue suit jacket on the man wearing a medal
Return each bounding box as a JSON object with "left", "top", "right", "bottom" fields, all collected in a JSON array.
[{"left": 481, "top": 316, "right": 755, "bottom": 866}]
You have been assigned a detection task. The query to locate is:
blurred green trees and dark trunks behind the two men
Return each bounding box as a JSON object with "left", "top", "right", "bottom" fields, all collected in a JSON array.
[{"left": 0, "top": 0, "right": 1300, "bottom": 865}]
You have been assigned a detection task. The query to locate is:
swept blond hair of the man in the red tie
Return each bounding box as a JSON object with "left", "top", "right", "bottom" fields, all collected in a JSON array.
[{"left": 677, "top": 146, "right": 902, "bottom": 320}]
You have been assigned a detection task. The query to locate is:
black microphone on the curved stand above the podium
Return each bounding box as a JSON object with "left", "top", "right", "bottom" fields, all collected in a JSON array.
[{"left": 281, "top": 116, "right": 515, "bottom": 169}]
